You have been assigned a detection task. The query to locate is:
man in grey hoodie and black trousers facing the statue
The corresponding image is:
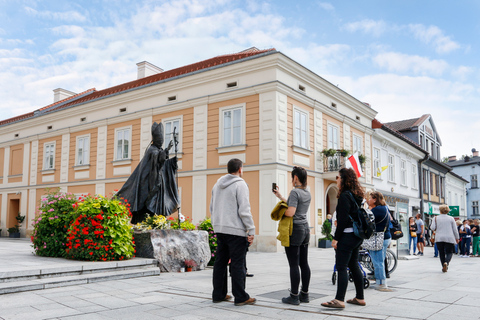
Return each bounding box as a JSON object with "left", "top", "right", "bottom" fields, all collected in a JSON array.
[{"left": 210, "top": 159, "right": 256, "bottom": 306}]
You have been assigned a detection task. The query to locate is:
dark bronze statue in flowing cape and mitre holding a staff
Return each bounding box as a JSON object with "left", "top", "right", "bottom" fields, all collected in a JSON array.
[{"left": 117, "top": 122, "right": 179, "bottom": 224}]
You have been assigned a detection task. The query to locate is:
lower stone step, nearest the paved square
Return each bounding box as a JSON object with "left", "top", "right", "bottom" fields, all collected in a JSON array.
[{"left": 0, "top": 266, "right": 160, "bottom": 295}]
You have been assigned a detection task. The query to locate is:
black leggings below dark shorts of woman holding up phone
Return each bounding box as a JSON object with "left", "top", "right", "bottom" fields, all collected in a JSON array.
[{"left": 285, "top": 244, "right": 311, "bottom": 294}]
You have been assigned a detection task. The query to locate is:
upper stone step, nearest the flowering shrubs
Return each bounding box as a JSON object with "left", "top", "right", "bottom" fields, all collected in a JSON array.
[{"left": 0, "top": 258, "right": 158, "bottom": 284}]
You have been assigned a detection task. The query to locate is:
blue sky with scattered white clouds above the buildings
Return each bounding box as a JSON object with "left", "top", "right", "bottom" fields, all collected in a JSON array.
[{"left": 0, "top": 0, "right": 480, "bottom": 157}]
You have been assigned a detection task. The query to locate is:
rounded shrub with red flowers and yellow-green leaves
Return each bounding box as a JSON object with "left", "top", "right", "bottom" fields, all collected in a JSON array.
[{"left": 65, "top": 195, "right": 135, "bottom": 261}]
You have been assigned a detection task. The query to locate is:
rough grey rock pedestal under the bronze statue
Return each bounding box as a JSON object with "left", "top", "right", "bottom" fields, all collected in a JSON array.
[{"left": 133, "top": 230, "right": 212, "bottom": 272}]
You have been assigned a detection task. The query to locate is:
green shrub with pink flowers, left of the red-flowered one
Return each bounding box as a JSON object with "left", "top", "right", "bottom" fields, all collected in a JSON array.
[{"left": 31, "top": 190, "right": 77, "bottom": 257}]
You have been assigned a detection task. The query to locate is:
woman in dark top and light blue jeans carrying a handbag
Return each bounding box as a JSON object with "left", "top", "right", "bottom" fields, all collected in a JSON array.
[{"left": 363, "top": 191, "right": 392, "bottom": 292}]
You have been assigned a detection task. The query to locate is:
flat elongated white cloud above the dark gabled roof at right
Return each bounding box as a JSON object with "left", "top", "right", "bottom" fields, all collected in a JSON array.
[{"left": 373, "top": 52, "right": 448, "bottom": 76}]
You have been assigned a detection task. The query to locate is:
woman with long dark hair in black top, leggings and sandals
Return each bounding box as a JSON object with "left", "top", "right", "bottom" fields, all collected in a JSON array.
[{"left": 322, "top": 168, "right": 365, "bottom": 309}]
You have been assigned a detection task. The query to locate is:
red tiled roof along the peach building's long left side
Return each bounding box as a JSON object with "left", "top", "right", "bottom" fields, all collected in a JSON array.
[{"left": 0, "top": 47, "right": 277, "bottom": 126}]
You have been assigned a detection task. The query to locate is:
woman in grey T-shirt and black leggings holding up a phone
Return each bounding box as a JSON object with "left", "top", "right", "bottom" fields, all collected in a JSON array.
[{"left": 272, "top": 167, "right": 311, "bottom": 305}]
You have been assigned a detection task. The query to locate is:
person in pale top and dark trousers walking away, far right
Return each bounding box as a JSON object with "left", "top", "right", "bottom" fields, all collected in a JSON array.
[{"left": 430, "top": 204, "right": 460, "bottom": 272}]
